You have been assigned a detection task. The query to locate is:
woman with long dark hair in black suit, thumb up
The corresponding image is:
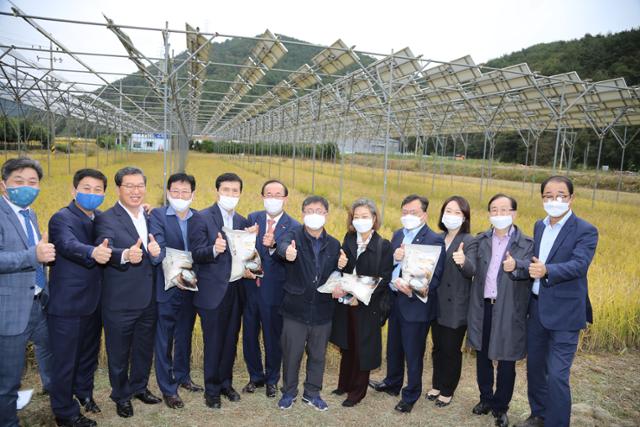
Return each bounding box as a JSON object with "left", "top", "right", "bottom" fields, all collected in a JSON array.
[{"left": 427, "top": 196, "right": 476, "bottom": 407}]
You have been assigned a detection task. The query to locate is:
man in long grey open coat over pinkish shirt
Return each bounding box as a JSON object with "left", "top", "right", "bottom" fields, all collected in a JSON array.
[{"left": 467, "top": 194, "right": 533, "bottom": 427}]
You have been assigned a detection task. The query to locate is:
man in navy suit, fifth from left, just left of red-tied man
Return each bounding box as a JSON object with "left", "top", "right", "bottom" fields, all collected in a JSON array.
[{"left": 189, "top": 173, "right": 248, "bottom": 409}]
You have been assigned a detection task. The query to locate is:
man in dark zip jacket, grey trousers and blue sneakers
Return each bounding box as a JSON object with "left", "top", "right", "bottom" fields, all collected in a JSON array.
[{"left": 276, "top": 196, "right": 340, "bottom": 411}]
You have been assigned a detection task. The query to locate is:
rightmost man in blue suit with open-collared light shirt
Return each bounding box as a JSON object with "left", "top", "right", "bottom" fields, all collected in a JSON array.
[{"left": 522, "top": 176, "right": 598, "bottom": 427}]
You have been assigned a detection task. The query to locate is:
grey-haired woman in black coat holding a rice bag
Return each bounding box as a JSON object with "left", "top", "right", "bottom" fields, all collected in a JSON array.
[{"left": 331, "top": 199, "right": 393, "bottom": 407}]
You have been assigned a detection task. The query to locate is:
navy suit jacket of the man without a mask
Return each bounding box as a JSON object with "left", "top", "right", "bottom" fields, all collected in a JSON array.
[{"left": 94, "top": 202, "right": 158, "bottom": 311}]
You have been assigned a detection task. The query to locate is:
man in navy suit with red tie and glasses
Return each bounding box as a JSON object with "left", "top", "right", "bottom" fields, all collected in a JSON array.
[{"left": 242, "top": 179, "right": 300, "bottom": 397}]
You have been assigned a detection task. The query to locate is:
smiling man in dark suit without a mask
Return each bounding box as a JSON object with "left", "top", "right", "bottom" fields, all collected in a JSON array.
[{"left": 95, "top": 167, "right": 162, "bottom": 418}]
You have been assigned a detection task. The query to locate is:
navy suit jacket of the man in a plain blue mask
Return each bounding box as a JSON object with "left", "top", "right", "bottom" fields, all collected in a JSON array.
[{"left": 47, "top": 201, "right": 103, "bottom": 316}]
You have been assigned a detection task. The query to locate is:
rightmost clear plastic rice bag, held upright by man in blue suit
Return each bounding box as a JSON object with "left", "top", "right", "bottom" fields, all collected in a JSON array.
[{"left": 398, "top": 244, "right": 442, "bottom": 302}]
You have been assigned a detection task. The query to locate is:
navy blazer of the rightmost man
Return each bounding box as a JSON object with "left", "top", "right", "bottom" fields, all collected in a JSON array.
[{"left": 533, "top": 213, "right": 598, "bottom": 331}]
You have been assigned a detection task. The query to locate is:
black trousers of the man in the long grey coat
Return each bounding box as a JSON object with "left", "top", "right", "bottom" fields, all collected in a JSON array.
[{"left": 476, "top": 302, "right": 516, "bottom": 412}]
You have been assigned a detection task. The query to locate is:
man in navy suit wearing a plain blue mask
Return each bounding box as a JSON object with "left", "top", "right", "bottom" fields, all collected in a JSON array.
[{"left": 47, "top": 169, "right": 111, "bottom": 426}]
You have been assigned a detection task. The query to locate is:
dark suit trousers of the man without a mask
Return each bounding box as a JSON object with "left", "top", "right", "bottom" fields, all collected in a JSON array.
[{"left": 102, "top": 300, "right": 156, "bottom": 403}]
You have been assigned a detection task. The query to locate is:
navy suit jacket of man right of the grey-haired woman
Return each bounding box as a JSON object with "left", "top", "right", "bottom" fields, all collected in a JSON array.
[{"left": 391, "top": 224, "right": 446, "bottom": 322}]
